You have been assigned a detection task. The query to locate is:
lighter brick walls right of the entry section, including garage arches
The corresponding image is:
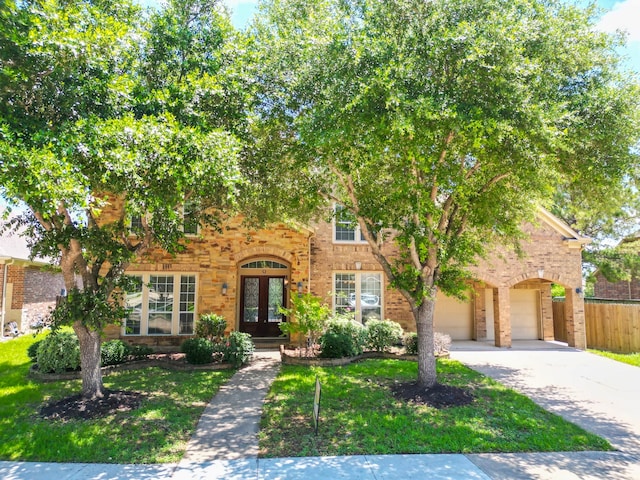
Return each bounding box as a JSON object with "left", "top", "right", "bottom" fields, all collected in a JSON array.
[{"left": 311, "top": 212, "right": 585, "bottom": 348}]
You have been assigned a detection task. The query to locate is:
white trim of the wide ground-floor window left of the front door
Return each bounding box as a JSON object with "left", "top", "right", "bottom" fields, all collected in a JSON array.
[{"left": 121, "top": 271, "right": 199, "bottom": 337}]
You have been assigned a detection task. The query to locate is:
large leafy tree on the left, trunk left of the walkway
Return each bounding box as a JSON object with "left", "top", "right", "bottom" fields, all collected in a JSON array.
[{"left": 0, "top": 0, "right": 244, "bottom": 397}]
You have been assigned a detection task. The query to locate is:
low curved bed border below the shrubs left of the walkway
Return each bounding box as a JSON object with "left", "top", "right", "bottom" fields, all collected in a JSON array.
[{"left": 27, "top": 356, "right": 233, "bottom": 382}]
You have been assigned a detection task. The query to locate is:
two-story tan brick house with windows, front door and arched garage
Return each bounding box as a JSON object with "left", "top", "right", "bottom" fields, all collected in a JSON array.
[{"left": 108, "top": 202, "right": 587, "bottom": 348}]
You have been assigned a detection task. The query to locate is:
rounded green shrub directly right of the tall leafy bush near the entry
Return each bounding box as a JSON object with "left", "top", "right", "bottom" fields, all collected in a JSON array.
[{"left": 320, "top": 316, "right": 367, "bottom": 358}]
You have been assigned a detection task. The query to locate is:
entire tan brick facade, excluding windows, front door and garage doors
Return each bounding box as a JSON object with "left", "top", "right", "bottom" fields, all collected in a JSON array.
[{"left": 97, "top": 195, "right": 585, "bottom": 348}]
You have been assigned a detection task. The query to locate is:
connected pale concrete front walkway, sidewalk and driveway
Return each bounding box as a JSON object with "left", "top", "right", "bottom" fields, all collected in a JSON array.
[{"left": 0, "top": 342, "right": 640, "bottom": 480}]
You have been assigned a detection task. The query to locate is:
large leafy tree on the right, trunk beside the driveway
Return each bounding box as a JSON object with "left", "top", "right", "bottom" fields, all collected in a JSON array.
[{"left": 253, "top": 0, "right": 638, "bottom": 388}]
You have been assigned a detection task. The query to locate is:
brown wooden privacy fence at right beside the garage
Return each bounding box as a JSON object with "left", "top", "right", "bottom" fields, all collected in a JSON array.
[{"left": 553, "top": 300, "right": 640, "bottom": 353}]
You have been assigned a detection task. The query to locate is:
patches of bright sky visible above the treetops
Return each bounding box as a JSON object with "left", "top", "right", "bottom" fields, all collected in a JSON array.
[{"left": 138, "top": 0, "right": 640, "bottom": 72}]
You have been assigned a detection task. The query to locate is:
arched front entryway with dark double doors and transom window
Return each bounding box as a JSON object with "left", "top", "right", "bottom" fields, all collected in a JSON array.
[{"left": 238, "top": 258, "right": 291, "bottom": 338}]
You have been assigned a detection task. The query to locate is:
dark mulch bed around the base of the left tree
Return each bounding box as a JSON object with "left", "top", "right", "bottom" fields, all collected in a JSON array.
[{"left": 40, "top": 390, "right": 146, "bottom": 421}]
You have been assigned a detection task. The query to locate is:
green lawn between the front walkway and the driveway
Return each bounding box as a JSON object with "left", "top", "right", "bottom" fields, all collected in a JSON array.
[{"left": 259, "top": 360, "right": 611, "bottom": 457}]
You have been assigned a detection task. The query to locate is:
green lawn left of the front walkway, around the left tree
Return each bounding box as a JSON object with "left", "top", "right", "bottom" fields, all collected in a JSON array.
[{"left": 0, "top": 336, "right": 233, "bottom": 463}]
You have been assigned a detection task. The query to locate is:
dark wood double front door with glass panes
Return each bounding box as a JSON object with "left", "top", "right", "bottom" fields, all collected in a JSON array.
[{"left": 240, "top": 275, "right": 286, "bottom": 337}]
